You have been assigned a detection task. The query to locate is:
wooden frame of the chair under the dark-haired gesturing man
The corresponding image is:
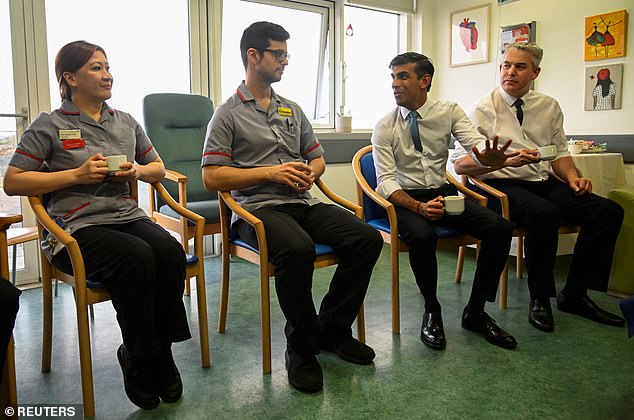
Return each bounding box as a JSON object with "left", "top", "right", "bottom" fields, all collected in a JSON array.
[{"left": 352, "top": 145, "right": 487, "bottom": 334}]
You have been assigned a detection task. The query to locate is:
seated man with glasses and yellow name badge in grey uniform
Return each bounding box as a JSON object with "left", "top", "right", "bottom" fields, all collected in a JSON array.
[{"left": 202, "top": 22, "right": 382, "bottom": 392}]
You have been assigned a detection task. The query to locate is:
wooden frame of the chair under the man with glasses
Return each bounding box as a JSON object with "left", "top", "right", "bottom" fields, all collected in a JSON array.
[{"left": 218, "top": 179, "right": 365, "bottom": 374}]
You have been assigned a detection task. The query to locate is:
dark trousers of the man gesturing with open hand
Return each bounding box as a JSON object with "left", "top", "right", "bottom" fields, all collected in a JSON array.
[{"left": 396, "top": 184, "right": 512, "bottom": 306}]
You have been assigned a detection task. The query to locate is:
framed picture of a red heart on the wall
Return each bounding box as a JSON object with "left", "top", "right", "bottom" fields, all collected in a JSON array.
[{"left": 449, "top": 4, "right": 491, "bottom": 67}]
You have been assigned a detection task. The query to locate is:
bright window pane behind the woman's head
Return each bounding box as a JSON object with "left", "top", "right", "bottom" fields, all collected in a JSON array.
[{"left": 46, "top": 0, "right": 190, "bottom": 125}]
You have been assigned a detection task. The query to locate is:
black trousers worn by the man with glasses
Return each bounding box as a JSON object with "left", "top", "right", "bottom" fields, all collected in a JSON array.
[{"left": 234, "top": 203, "right": 383, "bottom": 354}]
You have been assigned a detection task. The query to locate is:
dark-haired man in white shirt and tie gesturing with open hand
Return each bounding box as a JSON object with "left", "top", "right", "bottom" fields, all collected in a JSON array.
[{"left": 372, "top": 52, "right": 517, "bottom": 349}]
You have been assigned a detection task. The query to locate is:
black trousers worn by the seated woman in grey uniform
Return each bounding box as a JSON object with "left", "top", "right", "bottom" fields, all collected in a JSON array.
[{"left": 53, "top": 219, "right": 191, "bottom": 360}]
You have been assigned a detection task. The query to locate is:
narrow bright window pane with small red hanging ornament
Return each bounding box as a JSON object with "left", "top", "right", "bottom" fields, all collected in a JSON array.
[{"left": 344, "top": 5, "right": 400, "bottom": 129}]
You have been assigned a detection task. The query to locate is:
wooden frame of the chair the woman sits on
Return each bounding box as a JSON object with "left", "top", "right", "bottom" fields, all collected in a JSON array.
[{"left": 29, "top": 182, "right": 209, "bottom": 417}]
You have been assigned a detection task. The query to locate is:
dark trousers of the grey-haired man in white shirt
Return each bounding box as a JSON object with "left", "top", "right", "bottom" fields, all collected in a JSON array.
[{"left": 487, "top": 176, "right": 623, "bottom": 299}]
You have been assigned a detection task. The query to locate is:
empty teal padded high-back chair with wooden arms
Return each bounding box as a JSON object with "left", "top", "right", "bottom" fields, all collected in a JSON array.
[{"left": 143, "top": 93, "right": 220, "bottom": 295}]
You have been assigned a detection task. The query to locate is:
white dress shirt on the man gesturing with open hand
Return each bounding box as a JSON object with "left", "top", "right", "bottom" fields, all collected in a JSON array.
[{"left": 372, "top": 98, "right": 485, "bottom": 198}]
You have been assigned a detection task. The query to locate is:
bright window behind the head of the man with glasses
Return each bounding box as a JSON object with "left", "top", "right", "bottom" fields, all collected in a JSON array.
[{"left": 221, "top": 0, "right": 334, "bottom": 127}]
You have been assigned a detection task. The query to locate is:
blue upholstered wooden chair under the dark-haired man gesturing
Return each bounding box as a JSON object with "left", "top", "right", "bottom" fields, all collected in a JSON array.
[{"left": 352, "top": 146, "right": 478, "bottom": 334}]
